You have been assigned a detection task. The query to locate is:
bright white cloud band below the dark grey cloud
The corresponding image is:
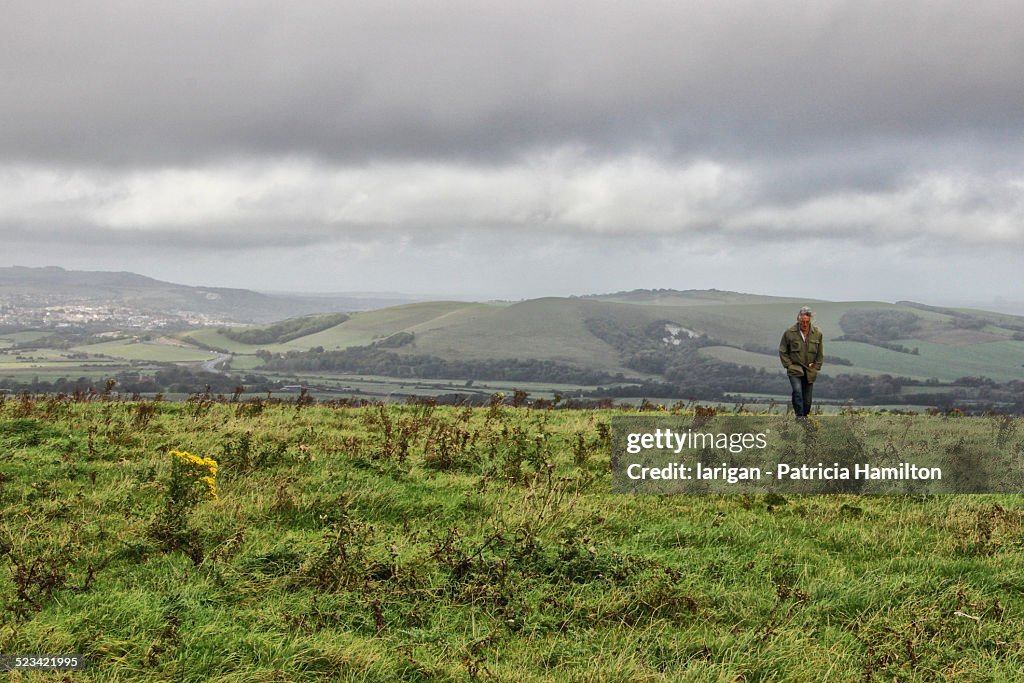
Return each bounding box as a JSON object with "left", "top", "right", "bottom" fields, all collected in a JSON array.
[{"left": 0, "top": 155, "right": 1024, "bottom": 248}]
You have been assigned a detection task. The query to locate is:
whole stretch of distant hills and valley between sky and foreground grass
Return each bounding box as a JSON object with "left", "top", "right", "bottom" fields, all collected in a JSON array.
[{"left": 8, "top": 278, "right": 1024, "bottom": 412}]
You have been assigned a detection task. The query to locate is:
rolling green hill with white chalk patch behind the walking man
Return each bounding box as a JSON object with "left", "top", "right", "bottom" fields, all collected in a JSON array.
[{"left": 203, "top": 290, "right": 1024, "bottom": 382}]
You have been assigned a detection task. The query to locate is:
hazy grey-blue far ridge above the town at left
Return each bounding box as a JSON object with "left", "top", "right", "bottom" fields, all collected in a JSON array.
[{"left": 0, "top": 266, "right": 419, "bottom": 323}]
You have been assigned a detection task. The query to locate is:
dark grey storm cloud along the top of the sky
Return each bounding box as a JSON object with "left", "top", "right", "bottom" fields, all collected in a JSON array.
[{"left": 6, "top": 0, "right": 1024, "bottom": 166}]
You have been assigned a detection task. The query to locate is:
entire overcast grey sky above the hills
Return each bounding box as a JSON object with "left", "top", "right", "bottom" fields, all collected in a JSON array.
[{"left": 0, "top": 0, "right": 1024, "bottom": 312}]
